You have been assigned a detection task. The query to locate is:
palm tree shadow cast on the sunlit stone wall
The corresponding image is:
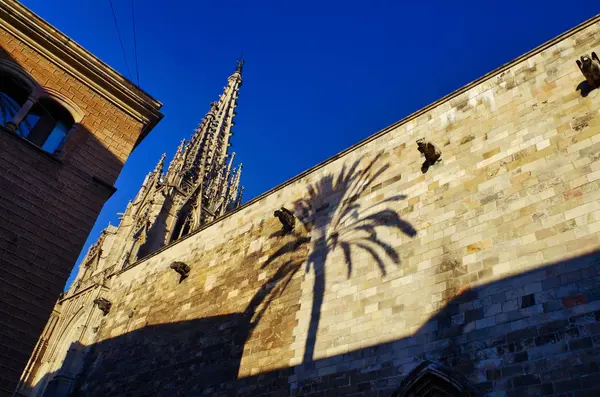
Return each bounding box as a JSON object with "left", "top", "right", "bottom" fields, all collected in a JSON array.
[{"left": 263, "top": 154, "right": 417, "bottom": 363}]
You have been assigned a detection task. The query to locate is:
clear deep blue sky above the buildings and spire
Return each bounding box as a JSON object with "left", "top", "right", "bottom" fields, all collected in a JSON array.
[{"left": 21, "top": 0, "right": 600, "bottom": 283}]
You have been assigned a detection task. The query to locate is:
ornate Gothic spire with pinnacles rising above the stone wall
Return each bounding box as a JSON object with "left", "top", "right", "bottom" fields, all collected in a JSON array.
[{"left": 77, "top": 60, "right": 244, "bottom": 276}]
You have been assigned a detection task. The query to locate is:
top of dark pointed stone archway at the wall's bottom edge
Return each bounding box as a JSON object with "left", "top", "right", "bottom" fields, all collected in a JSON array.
[{"left": 391, "top": 361, "right": 481, "bottom": 397}]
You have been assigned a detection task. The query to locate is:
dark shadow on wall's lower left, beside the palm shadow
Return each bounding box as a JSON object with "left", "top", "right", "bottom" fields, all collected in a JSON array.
[{"left": 20, "top": 264, "right": 298, "bottom": 397}]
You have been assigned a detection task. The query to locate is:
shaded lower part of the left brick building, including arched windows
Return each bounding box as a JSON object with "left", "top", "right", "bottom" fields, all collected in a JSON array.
[{"left": 0, "top": 46, "right": 123, "bottom": 395}]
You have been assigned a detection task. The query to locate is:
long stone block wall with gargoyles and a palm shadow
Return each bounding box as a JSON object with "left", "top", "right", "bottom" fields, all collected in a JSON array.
[{"left": 19, "top": 13, "right": 600, "bottom": 397}]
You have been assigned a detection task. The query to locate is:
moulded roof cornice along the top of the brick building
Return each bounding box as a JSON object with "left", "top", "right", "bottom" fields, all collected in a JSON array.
[{"left": 0, "top": 0, "right": 163, "bottom": 146}]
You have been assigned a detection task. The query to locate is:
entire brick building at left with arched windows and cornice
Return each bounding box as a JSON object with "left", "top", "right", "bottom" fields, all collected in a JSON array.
[{"left": 0, "top": 0, "right": 162, "bottom": 395}]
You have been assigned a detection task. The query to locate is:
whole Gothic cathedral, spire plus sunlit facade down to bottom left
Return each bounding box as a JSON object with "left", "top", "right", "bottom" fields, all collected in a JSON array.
[{"left": 19, "top": 61, "right": 244, "bottom": 395}]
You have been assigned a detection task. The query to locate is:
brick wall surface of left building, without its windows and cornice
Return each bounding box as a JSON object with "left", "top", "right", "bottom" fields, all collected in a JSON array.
[{"left": 0, "top": 24, "right": 146, "bottom": 395}]
